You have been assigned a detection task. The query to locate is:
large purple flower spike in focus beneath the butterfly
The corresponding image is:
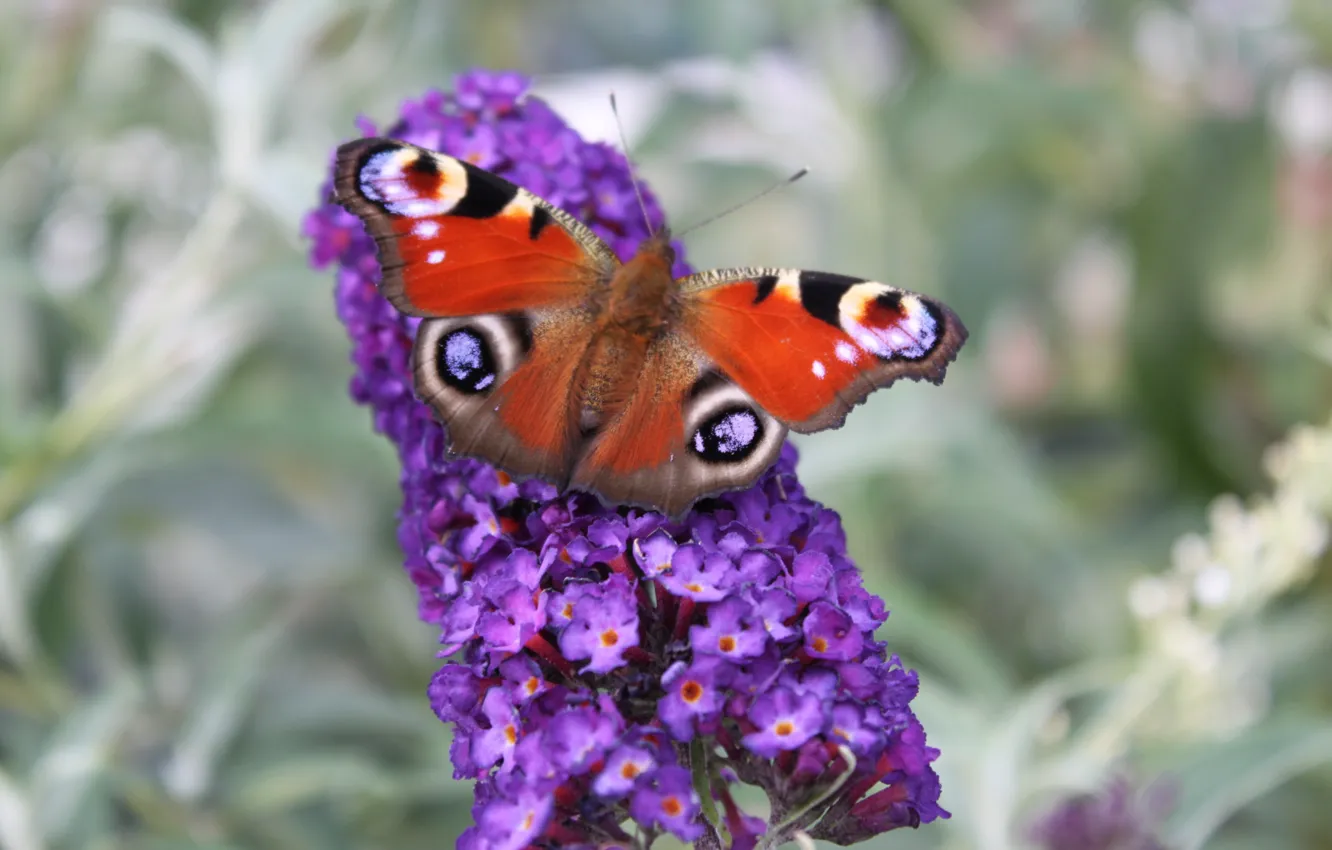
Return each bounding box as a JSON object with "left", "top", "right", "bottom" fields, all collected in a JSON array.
[{"left": 306, "top": 72, "right": 947, "bottom": 850}]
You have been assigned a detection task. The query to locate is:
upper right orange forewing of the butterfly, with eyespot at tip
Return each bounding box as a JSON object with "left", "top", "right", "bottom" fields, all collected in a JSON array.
[{"left": 681, "top": 269, "right": 967, "bottom": 433}]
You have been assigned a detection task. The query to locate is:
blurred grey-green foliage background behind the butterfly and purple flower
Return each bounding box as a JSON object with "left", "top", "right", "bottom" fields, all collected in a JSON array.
[{"left": 0, "top": 0, "right": 1332, "bottom": 850}]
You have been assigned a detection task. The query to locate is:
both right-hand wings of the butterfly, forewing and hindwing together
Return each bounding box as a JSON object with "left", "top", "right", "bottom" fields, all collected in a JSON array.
[{"left": 573, "top": 269, "right": 967, "bottom": 514}]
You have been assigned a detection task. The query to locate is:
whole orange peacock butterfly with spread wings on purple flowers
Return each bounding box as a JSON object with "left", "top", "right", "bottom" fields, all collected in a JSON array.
[{"left": 334, "top": 139, "right": 967, "bottom": 516}]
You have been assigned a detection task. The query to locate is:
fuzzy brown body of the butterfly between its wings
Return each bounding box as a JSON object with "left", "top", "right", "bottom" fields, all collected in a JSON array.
[{"left": 574, "top": 232, "right": 678, "bottom": 432}]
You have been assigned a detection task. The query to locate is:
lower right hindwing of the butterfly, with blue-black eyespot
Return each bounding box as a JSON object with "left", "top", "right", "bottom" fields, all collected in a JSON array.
[{"left": 571, "top": 333, "right": 786, "bottom": 514}]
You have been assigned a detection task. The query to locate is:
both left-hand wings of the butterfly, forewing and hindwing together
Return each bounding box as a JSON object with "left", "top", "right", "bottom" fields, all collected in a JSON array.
[{"left": 334, "top": 139, "right": 618, "bottom": 482}]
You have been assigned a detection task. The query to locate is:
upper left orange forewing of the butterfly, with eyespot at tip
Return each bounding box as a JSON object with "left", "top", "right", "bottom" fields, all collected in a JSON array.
[{"left": 334, "top": 139, "right": 619, "bottom": 316}]
